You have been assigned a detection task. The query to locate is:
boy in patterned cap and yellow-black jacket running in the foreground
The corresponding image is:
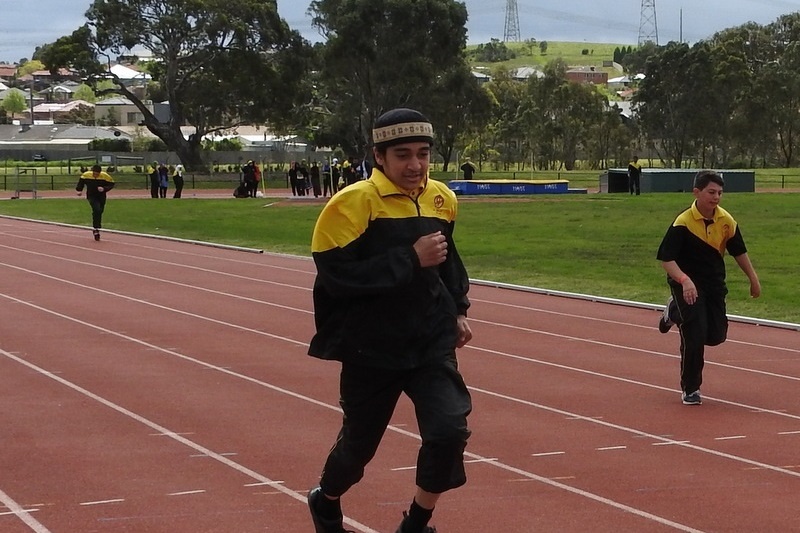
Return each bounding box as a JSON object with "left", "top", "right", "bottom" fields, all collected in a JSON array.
[{"left": 308, "top": 109, "right": 472, "bottom": 533}]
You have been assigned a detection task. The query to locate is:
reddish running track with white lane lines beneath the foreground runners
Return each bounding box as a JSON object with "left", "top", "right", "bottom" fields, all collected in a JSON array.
[{"left": 0, "top": 218, "right": 800, "bottom": 533}]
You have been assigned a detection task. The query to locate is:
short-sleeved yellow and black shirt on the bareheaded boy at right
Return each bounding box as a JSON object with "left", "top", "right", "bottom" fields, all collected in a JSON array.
[{"left": 656, "top": 202, "right": 747, "bottom": 294}]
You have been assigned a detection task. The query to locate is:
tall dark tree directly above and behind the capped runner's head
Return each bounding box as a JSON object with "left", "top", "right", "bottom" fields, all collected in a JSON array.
[{"left": 310, "top": 0, "right": 476, "bottom": 154}]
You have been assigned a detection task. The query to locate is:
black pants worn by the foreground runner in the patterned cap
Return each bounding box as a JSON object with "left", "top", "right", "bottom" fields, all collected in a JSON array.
[{"left": 320, "top": 357, "right": 472, "bottom": 496}]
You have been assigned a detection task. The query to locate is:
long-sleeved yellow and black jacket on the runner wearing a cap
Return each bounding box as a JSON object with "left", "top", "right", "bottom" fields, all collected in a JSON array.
[{"left": 308, "top": 169, "right": 469, "bottom": 369}]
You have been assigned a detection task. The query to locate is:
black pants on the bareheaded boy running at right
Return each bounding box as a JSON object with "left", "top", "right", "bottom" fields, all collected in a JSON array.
[{"left": 669, "top": 281, "right": 728, "bottom": 394}]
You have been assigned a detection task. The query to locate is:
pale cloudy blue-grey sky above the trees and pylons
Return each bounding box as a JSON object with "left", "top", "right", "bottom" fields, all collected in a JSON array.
[{"left": 0, "top": 0, "right": 800, "bottom": 62}]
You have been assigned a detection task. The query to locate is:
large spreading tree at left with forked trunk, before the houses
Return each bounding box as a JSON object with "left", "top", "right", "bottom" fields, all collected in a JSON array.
[{"left": 40, "top": 0, "right": 311, "bottom": 170}]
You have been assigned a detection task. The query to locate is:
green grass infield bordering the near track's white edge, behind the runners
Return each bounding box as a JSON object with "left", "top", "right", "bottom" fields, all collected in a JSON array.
[{"left": 0, "top": 193, "right": 800, "bottom": 323}]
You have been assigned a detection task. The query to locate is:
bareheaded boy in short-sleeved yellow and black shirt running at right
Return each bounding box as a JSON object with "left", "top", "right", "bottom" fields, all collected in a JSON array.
[{"left": 657, "top": 170, "right": 761, "bottom": 405}]
